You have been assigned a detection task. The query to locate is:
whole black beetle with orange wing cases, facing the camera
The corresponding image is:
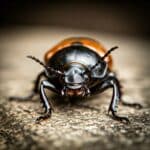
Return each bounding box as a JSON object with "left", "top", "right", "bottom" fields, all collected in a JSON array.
[{"left": 10, "top": 37, "right": 141, "bottom": 122}]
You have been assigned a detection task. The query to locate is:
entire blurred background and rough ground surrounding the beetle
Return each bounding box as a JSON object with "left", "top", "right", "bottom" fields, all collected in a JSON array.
[{"left": 0, "top": 0, "right": 150, "bottom": 150}]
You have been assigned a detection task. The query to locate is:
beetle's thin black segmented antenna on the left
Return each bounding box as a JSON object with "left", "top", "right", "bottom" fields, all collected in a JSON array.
[{"left": 27, "top": 55, "right": 64, "bottom": 75}]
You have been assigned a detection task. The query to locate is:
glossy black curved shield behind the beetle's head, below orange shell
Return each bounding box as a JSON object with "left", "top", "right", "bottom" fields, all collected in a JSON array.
[{"left": 48, "top": 46, "right": 101, "bottom": 70}]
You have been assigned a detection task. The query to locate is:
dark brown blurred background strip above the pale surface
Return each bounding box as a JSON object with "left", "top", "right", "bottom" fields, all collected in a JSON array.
[{"left": 0, "top": 0, "right": 150, "bottom": 37}]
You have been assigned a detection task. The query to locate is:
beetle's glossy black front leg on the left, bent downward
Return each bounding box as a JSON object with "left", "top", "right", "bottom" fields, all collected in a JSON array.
[{"left": 37, "top": 80, "right": 58, "bottom": 121}]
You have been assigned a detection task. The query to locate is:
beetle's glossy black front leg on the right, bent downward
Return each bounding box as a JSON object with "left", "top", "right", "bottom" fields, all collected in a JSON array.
[{"left": 91, "top": 76, "right": 129, "bottom": 122}]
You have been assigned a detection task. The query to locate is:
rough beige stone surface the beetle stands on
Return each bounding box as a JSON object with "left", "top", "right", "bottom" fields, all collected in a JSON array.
[{"left": 0, "top": 27, "right": 150, "bottom": 150}]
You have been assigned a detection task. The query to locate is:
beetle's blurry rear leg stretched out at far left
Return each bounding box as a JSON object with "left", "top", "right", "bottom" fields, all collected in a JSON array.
[{"left": 9, "top": 71, "right": 45, "bottom": 100}]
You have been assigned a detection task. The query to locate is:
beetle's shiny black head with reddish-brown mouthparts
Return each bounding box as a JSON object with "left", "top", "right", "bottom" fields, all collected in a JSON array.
[{"left": 63, "top": 63, "right": 89, "bottom": 96}]
